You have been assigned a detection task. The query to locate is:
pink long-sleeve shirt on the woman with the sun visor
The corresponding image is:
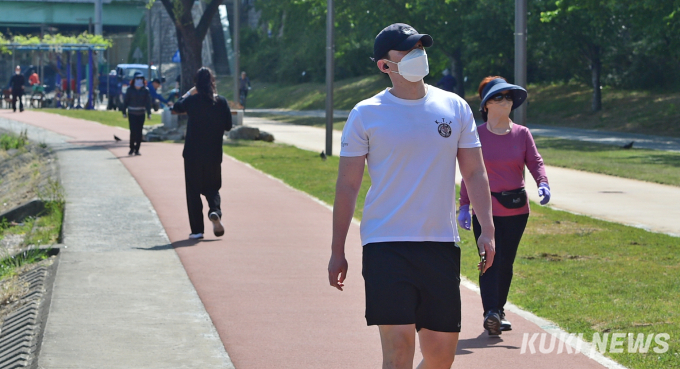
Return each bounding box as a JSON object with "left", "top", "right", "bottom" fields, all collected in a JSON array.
[{"left": 460, "top": 123, "right": 548, "bottom": 217}]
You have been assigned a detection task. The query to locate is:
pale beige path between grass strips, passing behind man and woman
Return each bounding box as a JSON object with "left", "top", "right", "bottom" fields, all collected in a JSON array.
[{"left": 244, "top": 116, "right": 680, "bottom": 236}]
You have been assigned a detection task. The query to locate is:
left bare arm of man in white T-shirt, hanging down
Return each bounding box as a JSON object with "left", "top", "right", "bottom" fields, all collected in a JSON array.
[{"left": 328, "top": 155, "right": 366, "bottom": 291}]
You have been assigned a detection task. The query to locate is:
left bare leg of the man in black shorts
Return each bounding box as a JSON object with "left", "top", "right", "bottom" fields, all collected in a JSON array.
[{"left": 379, "top": 324, "right": 416, "bottom": 369}]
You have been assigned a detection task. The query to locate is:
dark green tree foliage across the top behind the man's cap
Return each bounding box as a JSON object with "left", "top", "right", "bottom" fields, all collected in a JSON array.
[{"left": 241, "top": 0, "right": 680, "bottom": 100}]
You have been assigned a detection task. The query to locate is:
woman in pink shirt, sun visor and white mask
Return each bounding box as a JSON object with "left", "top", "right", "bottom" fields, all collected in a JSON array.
[{"left": 458, "top": 77, "right": 550, "bottom": 335}]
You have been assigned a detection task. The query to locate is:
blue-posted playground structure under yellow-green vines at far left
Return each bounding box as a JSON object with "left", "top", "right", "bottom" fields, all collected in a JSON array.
[{"left": 1, "top": 42, "right": 109, "bottom": 109}]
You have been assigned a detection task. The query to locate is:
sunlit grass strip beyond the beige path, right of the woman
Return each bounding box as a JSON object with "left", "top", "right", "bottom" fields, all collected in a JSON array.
[{"left": 535, "top": 137, "right": 680, "bottom": 186}]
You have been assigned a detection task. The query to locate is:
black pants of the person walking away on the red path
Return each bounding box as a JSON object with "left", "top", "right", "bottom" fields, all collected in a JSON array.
[{"left": 184, "top": 160, "right": 222, "bottom": 233}]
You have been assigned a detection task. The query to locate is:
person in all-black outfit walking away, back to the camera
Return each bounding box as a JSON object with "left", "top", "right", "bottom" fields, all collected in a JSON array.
[{"left": 173, "top": 67, "right": 231, "bottom": 239}]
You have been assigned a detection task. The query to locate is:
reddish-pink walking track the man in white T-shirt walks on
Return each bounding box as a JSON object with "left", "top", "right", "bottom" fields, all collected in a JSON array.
[{"left": 0, "top": 112, "right": 620, "bottom": 369}]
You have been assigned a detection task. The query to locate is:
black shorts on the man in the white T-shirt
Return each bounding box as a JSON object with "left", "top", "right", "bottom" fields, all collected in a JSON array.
[{"left": 362, "top": 242, "right": 460, "bottom": 332}]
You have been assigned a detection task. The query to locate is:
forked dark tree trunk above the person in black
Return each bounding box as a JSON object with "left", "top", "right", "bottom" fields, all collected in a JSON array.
[{"left": 155, "top": 0, "right": 222, "bottom": 91}]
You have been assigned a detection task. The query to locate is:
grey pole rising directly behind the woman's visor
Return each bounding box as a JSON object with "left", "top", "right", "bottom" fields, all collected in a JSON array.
[{"left": 513, "top": 0, "right": 528, "bottom": 126}]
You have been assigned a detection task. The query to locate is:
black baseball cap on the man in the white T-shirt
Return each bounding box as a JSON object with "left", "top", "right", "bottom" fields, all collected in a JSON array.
[{"left": 371, "top": 23, "right": 433, "bottom": 61}]
